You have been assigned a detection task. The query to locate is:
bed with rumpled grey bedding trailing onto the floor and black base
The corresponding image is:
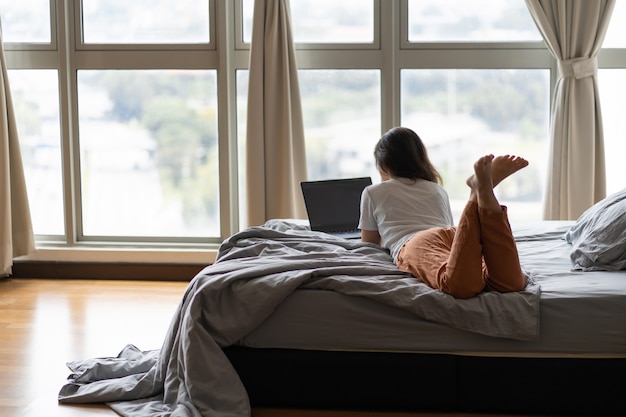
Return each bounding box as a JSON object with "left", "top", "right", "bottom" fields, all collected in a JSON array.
[{"left": 59, "top": 193, "right": 626, "bottom": 417}]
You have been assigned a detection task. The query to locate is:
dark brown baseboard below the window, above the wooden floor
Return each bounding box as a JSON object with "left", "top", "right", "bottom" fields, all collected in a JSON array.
[{"left": 11, "top": 261, "right": 206, "bottom": 281}]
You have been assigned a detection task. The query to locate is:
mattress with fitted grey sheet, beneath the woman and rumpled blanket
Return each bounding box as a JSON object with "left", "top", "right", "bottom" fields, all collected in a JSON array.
[{"left": 238, "top": 221, "right": 626, "bottom": 358}]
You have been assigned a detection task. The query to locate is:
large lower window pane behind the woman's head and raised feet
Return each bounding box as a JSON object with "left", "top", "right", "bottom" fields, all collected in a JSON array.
[{"left": 401, "top": 70, "right": 550, "bottom": 220}]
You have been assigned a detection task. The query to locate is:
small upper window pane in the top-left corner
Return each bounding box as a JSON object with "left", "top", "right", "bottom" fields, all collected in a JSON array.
[{"left": 0, "top": 0, "right": 50, "bottom": 43}]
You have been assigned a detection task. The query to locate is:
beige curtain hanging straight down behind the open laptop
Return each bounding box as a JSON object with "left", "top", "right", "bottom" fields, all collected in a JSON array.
[{"left": 246, "top": 0, "right": 306, "bottom": 225}]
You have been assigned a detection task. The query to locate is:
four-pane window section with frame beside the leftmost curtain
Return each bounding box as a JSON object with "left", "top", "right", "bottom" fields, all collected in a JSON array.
[{"left": 0, "top": 0, "right": 222, "bottom": 248}]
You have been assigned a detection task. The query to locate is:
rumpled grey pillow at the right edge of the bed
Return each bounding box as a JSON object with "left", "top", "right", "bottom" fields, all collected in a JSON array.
[{"left": 565, "top": 188, "right": 626, "bottom": 271}]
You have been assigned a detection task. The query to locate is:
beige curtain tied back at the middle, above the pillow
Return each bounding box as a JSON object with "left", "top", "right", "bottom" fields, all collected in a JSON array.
[{"left": 526, "top": 0, "right": 615, "bottom": 220}]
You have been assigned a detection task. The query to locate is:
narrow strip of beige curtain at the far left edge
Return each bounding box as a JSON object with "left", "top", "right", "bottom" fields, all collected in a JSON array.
[{"left": 0, "top": 25, "right": 35, "bottom": 277}]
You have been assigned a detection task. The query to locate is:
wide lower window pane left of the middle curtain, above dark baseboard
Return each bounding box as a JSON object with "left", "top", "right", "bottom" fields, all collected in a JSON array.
[{"left": 78, "top": 70, "right": 220, "bottom": 237}]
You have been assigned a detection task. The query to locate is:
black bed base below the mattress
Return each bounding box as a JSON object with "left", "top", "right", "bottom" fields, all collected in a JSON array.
[{"left": 224, "top": 346, "right": 626, "bottom": 416}]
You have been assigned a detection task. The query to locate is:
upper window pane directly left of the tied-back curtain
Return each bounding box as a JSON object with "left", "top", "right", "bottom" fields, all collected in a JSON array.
[{"left": 408, "top": 0, "right": 541, "bottom": 42}]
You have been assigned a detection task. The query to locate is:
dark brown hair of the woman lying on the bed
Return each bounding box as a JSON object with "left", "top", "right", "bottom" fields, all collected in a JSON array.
[{"left": 374, "top": 127, "right": 443, "bottom": 185}]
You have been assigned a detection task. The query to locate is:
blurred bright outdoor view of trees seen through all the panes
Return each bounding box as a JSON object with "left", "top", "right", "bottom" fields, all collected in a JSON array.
[{"left": 0, "top": 0, "right": 626, "bottom": 237}]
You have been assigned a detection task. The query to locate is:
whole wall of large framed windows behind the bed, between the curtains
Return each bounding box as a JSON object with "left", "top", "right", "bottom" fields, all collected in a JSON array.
[{"left": 0, "top": 0, "right": 626, "bottom": 260}]
